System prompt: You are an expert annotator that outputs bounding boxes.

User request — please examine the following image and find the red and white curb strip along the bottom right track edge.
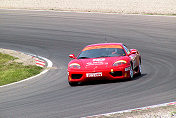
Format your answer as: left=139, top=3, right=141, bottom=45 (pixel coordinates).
left=82, top=101, right=176, bottom=118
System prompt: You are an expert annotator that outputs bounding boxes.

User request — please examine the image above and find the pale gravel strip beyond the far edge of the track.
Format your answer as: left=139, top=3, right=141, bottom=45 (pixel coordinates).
left=0, top=0, right=176, bottom=14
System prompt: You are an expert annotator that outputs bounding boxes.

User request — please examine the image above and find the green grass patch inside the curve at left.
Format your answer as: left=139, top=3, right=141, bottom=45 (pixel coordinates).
left=0, top=53, right=43, bottom=86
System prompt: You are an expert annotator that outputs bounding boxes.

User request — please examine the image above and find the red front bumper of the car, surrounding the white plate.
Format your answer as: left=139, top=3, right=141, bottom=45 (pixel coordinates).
left=68, top=66, right=130, bottom=82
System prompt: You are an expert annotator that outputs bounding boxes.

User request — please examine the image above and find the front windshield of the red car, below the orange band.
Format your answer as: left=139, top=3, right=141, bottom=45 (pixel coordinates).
left=78, top=48, right=126, bottom=59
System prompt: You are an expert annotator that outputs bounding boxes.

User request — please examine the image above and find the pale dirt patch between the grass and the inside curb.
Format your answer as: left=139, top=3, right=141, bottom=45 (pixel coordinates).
left=0, top=48, right=36, bottom=65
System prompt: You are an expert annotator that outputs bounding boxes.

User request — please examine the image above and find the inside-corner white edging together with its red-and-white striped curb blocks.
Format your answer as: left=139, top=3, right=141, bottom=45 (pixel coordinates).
left=0, top=52, right=53, bottom=88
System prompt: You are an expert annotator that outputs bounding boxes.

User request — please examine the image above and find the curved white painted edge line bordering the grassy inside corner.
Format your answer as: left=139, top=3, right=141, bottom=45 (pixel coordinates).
left=0, top=52, right=53, bottom=88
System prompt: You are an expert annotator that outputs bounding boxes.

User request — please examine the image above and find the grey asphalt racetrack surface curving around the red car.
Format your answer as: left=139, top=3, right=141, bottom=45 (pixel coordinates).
left=0, top=10, right=176, bottom=118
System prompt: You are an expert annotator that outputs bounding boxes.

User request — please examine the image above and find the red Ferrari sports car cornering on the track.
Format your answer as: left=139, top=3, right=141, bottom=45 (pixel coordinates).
left=68, top=43, right=141, bottom=86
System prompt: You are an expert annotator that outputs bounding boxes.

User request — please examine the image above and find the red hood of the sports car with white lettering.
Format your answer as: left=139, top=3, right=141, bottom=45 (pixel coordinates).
left=69, top=56, right=127, bottom=70
